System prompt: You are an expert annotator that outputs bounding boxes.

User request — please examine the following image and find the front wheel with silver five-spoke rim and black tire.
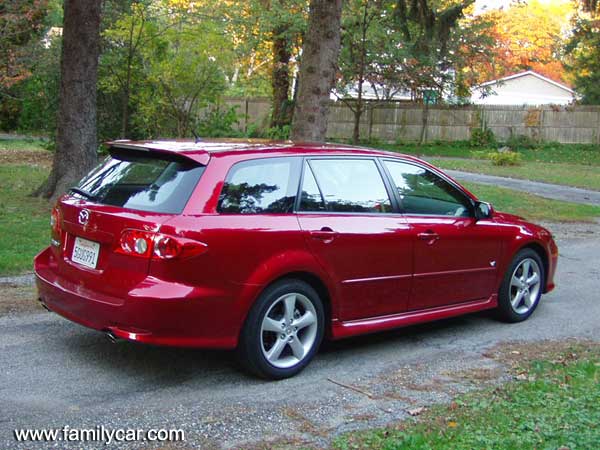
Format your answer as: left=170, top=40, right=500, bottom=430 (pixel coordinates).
left=497, top=248, right=545, bottom=323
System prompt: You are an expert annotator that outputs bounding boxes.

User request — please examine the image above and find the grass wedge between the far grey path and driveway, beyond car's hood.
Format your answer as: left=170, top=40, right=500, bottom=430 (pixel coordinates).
left=463, top=183, right=600, bottom=222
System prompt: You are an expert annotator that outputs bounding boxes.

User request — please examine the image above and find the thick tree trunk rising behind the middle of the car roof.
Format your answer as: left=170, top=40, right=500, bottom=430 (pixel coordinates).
left=291, top=0, right=342, bottom=142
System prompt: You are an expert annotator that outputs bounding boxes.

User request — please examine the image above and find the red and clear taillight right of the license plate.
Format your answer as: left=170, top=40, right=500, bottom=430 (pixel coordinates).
left=115, top=230, right=208, bottom=259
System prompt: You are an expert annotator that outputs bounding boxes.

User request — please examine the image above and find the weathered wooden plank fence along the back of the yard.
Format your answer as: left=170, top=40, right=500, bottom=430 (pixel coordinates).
left=218, top=98, right=600, bottom=144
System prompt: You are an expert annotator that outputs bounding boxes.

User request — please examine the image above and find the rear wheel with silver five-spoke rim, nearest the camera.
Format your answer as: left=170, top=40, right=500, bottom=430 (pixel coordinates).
left=237, top=279, right=325, bottom=380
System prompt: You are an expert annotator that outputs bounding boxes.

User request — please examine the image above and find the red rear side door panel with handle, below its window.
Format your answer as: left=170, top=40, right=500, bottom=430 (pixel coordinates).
left=298, top=214, right=413, bottom=320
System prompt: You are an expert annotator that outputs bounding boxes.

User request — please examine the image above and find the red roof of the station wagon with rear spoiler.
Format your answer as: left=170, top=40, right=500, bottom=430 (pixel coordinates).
left=107, top=139, right=416, bottom=164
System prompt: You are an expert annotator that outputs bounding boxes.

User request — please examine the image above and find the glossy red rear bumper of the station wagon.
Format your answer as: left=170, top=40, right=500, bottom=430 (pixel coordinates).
left=34, top=248, right=243, bottom=349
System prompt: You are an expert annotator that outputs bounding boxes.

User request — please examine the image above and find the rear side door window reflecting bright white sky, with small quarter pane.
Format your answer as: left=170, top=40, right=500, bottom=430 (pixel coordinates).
left=301, top=159, right=392, bottom=213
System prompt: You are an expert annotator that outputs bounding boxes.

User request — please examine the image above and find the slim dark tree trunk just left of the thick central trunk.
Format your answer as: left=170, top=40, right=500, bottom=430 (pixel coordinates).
left=271, top=27, right=292, bottom=127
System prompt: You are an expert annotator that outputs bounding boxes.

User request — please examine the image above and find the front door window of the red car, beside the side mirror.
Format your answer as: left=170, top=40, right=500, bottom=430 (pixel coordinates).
left=385, top=161, right=471, bottom=216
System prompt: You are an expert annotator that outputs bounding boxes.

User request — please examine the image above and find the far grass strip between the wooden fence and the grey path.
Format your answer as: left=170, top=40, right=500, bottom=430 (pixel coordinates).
left=377, top=142, right=600, bottom=191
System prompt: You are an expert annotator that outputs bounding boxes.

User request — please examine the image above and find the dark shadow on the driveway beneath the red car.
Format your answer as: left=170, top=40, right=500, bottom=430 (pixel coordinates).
left=56, top=312, right=492, bottom=391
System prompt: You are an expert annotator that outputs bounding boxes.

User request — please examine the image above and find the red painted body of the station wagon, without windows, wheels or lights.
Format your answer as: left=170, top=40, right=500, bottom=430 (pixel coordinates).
left=35, top=140, right=558, bottom=348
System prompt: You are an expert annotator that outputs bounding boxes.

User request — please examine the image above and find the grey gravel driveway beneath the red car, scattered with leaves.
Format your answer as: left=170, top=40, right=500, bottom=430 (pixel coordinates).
left=0, top=229, right=600, bottom=448
